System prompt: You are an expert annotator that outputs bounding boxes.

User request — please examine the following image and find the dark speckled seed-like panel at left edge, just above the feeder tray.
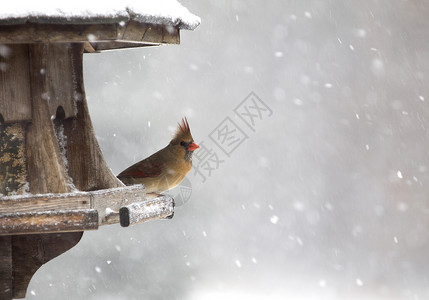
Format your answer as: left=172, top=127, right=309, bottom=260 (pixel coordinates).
left=0, top=123, right=28, bottom=196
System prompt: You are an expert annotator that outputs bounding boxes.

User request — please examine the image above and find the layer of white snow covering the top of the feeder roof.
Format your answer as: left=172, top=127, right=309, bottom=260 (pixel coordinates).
left=0, top=0, right=201, bottom=30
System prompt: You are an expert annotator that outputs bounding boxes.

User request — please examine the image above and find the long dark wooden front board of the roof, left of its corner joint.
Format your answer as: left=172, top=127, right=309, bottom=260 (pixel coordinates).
left=0, top=23, right=117, bottom=44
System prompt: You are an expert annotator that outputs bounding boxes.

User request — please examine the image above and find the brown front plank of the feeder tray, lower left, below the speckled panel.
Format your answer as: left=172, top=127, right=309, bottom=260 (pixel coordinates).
left=0, top=209, right=98, bottom=235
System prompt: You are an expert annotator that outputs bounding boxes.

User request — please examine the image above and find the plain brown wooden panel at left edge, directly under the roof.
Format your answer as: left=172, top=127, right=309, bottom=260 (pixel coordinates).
left=0, top=44, right=31, bottom=123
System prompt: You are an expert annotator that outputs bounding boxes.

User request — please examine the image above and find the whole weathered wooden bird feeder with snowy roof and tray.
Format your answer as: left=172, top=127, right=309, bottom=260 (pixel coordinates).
left=0, top=0, right=199, bottom=299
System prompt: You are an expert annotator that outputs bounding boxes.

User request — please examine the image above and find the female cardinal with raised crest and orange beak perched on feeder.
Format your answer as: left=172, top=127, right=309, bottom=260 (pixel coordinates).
left=118, top=118, right=200, bottom=194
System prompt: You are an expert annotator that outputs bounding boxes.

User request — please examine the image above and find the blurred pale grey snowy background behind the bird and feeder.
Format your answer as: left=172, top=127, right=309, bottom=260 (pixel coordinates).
left=27, top=0, right=429, bottom=300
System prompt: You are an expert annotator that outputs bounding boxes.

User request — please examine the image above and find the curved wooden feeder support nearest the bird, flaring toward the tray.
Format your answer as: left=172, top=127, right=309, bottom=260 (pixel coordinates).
left=62, top=44, right=124, bottom=191
